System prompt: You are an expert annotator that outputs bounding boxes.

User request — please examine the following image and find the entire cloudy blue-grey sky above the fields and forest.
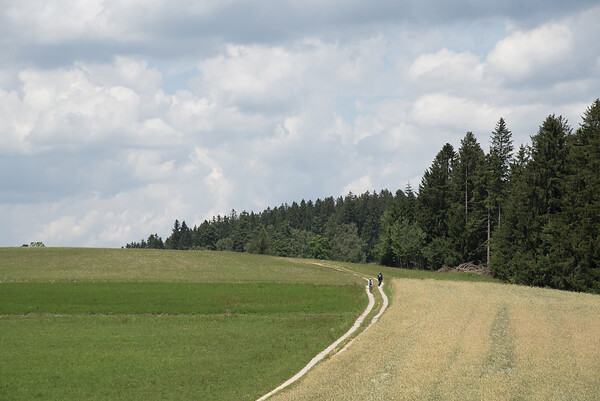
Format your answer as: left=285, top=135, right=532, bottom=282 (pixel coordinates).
left=0, top=0, right=600, bottom=247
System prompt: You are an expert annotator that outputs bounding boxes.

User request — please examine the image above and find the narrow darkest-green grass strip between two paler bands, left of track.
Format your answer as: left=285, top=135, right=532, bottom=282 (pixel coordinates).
left=0, top=282, right=367, bottom=315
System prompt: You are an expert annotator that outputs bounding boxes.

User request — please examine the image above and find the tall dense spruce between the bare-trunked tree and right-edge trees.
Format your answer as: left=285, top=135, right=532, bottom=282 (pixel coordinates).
left=491, top=115, right=571, bottom=286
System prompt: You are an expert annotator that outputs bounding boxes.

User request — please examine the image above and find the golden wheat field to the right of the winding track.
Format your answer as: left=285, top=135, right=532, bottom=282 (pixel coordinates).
left=271, top=279, right=600, bottom=401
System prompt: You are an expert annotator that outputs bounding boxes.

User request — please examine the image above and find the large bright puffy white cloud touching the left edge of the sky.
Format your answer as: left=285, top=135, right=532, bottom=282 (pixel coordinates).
left=0, top=57, right=188, bottom=154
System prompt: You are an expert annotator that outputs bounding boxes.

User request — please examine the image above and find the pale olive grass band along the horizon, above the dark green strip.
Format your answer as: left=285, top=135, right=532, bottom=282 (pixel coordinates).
left=0, top=248, right=356, bottom=285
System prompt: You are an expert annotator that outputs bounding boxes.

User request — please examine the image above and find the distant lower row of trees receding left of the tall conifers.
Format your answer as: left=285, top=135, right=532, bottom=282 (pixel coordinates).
left=127, top=190, right=401, bottom=262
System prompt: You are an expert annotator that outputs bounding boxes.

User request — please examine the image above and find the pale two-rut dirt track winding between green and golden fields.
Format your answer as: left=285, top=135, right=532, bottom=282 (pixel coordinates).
left=256, top=263, right=388, bottom=401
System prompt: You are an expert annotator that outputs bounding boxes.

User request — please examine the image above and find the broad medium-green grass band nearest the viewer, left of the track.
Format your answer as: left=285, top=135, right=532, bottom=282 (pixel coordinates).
left=0, top=313, right=356, bottom=401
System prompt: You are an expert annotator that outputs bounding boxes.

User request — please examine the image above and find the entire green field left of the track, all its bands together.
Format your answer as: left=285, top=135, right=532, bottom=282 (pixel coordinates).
left=0, top=248, right=367, bottom=400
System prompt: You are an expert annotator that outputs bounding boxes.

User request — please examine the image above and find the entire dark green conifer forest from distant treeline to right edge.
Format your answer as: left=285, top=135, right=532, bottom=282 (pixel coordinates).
left=126, top=99, right=600, bottom=293
